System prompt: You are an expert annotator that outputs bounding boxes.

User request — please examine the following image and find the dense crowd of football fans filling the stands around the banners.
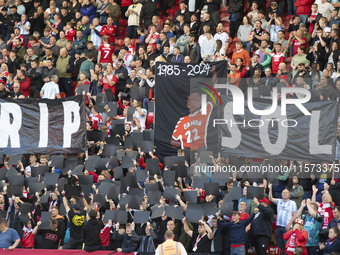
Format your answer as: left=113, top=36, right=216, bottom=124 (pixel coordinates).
left=0, top=0, right=340, bottom=255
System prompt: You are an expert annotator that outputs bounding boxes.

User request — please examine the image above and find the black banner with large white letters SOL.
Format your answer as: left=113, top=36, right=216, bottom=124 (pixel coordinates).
left=216, top=96, right=338, bottom=162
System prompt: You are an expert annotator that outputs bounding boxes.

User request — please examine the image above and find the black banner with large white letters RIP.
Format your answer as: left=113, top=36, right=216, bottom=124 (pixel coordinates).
left=0, top=96, right=86, bottom=154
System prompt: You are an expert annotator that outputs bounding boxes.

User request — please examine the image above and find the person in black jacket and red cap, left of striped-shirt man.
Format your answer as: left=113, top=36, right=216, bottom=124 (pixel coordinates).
left=251, top=198, right=274, bottom=255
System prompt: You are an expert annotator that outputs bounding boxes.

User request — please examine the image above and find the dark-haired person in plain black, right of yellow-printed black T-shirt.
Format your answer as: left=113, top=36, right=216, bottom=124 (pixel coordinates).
left=82, top=209, right=104, bottom=251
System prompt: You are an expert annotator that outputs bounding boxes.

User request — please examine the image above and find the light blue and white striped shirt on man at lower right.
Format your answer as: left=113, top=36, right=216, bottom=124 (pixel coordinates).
left=276, top=199, right=297, bottom=227
